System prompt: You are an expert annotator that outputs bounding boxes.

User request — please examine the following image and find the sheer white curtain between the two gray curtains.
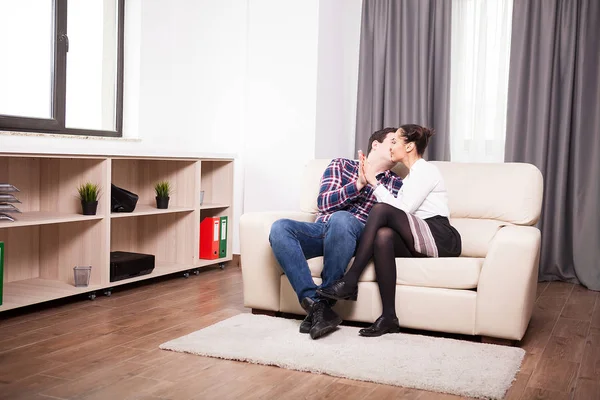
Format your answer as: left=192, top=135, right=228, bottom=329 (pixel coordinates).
left=450, top=0, right=513, bottom=162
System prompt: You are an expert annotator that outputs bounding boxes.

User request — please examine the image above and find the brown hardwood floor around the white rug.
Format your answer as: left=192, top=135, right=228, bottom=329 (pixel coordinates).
left=0, top=266, right=600, bottom=400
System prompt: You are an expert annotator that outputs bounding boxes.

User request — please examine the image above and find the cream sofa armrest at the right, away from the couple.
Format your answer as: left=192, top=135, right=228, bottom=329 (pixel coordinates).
left=475, top=226, right=541, bottom=340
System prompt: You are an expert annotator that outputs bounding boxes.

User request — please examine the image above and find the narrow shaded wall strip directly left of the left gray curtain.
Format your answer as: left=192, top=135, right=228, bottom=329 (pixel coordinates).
left=315, top=0, right=366, bottom=158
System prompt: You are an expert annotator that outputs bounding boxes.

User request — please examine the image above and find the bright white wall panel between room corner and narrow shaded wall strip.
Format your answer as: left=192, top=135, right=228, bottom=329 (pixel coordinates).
left=242, top=0, right=319, bottom=212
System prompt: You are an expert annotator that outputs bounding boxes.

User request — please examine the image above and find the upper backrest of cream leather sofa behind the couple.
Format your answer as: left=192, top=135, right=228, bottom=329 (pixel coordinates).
left=300, top=159, right=543, bottom=225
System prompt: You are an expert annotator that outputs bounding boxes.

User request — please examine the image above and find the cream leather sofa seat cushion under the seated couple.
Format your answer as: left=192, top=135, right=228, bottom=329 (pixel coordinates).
left=308, top=257, right=484, bottom=289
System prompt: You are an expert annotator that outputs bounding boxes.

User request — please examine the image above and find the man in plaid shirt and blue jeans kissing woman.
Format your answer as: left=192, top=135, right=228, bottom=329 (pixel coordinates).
left=269, top=128, right=402, bottom=339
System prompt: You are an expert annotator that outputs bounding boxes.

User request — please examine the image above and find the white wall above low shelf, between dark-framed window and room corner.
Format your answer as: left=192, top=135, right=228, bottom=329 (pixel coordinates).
left=139, top=0, right=246, bottom=153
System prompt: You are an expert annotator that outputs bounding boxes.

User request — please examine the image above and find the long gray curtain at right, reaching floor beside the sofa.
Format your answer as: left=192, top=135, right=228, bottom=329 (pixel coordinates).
left=506, top=0, right=600, bottom=290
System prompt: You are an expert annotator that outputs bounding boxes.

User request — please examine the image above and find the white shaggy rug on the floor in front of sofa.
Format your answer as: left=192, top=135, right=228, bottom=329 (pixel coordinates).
left=160, top=314, right=525, bottom=399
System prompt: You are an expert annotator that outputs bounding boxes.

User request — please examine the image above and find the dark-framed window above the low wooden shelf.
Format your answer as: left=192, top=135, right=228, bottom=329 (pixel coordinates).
left=0, top=0, right=124, bottom=136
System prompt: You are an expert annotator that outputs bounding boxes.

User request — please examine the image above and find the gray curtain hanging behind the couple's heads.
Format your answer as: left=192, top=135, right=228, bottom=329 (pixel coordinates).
left=355, top=0, right=452, bottom=160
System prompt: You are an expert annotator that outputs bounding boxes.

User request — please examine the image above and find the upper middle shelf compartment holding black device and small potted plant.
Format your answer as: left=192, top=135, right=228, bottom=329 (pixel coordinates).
left=111, top=158, right=199, bottom=210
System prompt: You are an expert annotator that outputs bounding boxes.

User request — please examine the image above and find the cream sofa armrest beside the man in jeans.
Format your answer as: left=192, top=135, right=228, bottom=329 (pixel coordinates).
left=240, top=212, right=315, bottom=311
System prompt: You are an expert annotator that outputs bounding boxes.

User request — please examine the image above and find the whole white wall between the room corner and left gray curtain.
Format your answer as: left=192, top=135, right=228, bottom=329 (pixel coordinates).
left=242, top=0, right=362, bottom=216
